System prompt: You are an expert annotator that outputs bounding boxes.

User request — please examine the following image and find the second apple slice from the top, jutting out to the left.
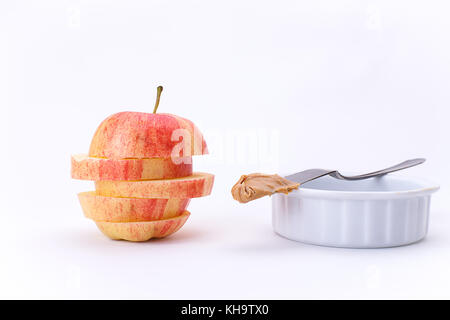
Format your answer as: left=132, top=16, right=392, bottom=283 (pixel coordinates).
left=71, top=154, right=192, bottom=180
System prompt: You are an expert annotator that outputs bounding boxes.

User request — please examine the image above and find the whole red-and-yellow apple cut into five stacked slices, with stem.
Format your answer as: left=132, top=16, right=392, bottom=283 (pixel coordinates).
left=71, top=88, right=214, bottom=241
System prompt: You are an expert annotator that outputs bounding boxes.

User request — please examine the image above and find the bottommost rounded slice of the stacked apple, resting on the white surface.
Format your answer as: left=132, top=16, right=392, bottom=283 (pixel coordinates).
left=95, top=211, right=190, bottom=241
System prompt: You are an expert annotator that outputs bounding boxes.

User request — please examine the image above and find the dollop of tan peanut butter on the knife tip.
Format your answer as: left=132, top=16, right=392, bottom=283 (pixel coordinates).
left=231, top=173, right=300, bottom=203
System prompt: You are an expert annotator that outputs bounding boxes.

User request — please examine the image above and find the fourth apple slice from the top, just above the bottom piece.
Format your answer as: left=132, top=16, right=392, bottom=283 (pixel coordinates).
left=78, top=192, right=190, bottom=222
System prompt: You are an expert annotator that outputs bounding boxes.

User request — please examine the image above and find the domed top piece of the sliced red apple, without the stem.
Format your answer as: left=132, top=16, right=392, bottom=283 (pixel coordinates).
left=89, top=111, right=208, bottom=159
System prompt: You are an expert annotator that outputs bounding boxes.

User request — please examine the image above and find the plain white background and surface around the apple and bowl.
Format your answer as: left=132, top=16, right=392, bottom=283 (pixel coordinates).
left=0, top=0, right=450, bottom=299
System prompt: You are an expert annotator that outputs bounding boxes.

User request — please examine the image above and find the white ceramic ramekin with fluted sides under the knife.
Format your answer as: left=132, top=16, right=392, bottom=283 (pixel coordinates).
left=272, top=174, right=439, bottom=248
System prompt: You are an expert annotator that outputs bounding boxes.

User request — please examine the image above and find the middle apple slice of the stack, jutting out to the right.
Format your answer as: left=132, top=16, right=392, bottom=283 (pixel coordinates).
left=95, top=172, right=214, bottom=199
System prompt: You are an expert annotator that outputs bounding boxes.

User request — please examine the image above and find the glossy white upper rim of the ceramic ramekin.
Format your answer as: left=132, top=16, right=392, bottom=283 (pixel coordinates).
left=287, top=174, right=440, bottom=200
